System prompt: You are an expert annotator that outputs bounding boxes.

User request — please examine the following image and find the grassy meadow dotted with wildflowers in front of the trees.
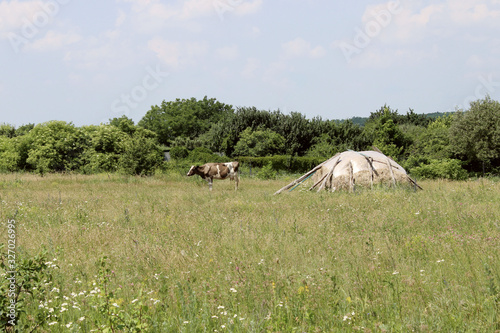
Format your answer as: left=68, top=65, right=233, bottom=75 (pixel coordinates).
left=0, top=174, right=500, bottom=332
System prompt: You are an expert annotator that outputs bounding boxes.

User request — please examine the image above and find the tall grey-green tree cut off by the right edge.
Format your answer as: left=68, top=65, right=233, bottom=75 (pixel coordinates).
left=450, top=96, right=500, bottom=172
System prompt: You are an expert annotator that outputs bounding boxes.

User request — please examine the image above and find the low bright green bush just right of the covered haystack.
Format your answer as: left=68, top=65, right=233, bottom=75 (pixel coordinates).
left=410, top=159, right=468, bottom=180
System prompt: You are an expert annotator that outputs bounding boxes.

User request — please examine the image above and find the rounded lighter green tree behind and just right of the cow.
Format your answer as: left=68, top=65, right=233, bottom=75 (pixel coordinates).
left=234, top=127, right=285, bottom=156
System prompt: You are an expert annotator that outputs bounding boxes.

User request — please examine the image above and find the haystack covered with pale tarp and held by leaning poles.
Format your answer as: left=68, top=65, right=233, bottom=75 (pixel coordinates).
left=275, top=150, right=421, bottom=194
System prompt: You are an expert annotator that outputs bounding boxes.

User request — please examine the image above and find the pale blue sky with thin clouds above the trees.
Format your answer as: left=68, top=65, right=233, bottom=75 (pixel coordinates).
left=0, top=0, right=500, bottom=127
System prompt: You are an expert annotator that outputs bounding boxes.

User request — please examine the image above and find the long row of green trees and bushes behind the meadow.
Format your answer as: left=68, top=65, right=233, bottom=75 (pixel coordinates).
left=0, top=96, right=500, bottom=179
